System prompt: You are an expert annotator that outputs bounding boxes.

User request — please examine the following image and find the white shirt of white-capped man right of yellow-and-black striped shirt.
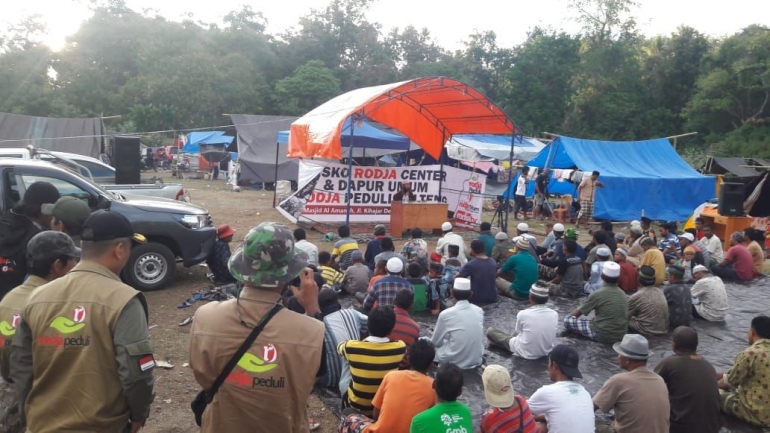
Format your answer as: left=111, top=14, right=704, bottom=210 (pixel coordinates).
left=431, top=301, right=485, bottom=369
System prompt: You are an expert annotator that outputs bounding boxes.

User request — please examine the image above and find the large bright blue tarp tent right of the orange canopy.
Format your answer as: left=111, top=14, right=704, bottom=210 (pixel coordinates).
left=509, top=137, right=715, bottom=221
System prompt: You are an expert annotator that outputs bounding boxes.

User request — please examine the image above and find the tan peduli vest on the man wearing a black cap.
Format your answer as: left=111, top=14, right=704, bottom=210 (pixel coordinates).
left=22, top=261, right=147, bottom=433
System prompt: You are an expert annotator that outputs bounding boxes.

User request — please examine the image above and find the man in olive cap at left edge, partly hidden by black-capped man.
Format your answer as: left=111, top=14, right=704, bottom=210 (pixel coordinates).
left=0, top=231, right=80, bottom=433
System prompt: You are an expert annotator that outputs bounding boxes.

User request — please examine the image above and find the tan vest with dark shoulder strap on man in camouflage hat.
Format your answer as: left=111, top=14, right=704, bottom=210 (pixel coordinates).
left=190, top=287, right=324, bottom=433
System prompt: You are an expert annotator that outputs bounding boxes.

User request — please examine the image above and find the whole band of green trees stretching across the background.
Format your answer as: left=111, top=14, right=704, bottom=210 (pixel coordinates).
left=0, top=0, right=770, bottom=157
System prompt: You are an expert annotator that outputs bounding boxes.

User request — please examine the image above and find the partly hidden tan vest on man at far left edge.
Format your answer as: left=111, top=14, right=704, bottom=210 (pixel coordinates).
left=0, top=275, right=47, bottom=382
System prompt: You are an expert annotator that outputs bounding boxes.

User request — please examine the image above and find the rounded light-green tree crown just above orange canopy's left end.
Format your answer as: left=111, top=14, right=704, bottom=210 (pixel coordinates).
left=275, top=60, right=342, bottom=116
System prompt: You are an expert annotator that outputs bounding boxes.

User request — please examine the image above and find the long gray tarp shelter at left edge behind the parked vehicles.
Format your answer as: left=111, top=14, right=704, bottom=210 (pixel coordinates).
left=0, top=113, right=104, bottom=158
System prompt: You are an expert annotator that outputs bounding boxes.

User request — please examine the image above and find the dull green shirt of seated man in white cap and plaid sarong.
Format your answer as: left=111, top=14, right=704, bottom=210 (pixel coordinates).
left=580, top=283, right=628, bottom=343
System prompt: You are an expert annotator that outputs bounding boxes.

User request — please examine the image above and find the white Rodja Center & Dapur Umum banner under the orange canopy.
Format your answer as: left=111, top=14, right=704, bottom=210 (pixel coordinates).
left=277, top=161, right=487, bottom=227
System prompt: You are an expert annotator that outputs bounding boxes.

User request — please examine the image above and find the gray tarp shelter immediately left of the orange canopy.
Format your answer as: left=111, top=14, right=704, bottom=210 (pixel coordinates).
left=230, top=114, right=299, bottom=183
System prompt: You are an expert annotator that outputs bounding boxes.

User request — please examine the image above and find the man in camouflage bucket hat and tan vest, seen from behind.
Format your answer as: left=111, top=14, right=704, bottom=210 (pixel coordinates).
left=190, top=222, right=324, bottom=433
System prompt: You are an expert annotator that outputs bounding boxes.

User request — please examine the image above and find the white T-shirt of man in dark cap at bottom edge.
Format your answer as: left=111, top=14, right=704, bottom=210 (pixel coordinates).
left=527, top=380, right=596, bottom=433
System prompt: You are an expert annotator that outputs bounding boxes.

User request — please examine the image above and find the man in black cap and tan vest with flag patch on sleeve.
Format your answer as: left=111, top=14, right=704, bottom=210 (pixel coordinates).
left=11, top=210, right=155, bottom=432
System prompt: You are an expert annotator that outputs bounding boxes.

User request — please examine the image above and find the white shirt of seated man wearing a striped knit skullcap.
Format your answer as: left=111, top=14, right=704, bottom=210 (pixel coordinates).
left=509, top=305, right=559, bottom=359
